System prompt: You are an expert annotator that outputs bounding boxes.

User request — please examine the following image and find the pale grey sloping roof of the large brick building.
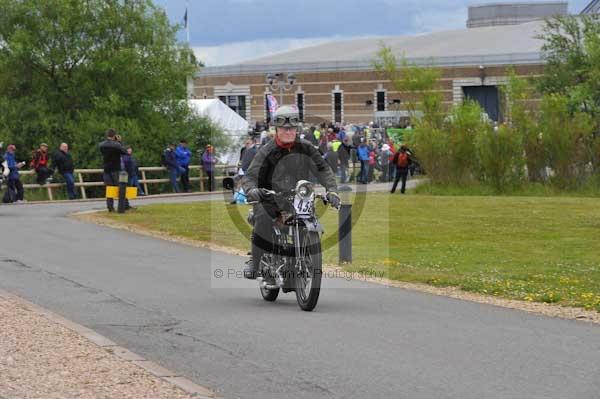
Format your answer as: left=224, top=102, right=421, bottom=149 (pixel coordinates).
left=200, top=21, right=544, bottom=76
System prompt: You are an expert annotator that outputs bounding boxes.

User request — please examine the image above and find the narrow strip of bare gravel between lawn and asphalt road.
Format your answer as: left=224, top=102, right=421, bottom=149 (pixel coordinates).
left=73, top=213, right=600, bottom=324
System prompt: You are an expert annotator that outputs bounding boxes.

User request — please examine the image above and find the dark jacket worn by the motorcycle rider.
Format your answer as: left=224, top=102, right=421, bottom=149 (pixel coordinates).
left=242, top=138, right=337, bottom=192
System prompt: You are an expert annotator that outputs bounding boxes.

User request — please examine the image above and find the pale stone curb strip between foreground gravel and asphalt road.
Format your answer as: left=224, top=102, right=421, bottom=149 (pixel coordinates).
left=0, top=289, right=219, bottom=399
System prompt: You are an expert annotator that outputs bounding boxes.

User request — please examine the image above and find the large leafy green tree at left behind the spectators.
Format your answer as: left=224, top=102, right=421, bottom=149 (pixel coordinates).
left=0, top=0, right=219, bottom=167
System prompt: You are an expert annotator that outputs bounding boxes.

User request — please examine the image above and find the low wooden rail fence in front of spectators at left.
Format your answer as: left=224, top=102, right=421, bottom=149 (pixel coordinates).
left=19, top=165, right=235, bottom=201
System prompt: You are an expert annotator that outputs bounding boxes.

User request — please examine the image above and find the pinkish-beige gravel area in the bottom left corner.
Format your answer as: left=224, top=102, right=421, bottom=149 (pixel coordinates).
left=0, top=294, right=191, bottom=399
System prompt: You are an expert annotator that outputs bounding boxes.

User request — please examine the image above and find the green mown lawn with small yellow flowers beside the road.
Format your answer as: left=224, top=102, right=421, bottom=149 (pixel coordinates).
left=104, top=194, right=600, bottom=311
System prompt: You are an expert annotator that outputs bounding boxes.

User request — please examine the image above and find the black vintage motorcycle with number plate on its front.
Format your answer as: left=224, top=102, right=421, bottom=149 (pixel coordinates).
left=248, top=180, right=338, bottom=312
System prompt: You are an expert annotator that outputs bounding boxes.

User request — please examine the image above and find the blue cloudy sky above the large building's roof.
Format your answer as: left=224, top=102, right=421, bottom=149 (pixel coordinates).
left=155, top=0, right=590, bottom=65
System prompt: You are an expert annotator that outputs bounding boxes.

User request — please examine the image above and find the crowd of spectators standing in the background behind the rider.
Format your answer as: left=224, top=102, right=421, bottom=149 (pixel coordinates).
left=0, top=124, right=418, bottom=206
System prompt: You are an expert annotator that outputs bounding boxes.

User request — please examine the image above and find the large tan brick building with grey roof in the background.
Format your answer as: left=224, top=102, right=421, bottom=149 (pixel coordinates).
left=193, top=2, right=580, bottom=123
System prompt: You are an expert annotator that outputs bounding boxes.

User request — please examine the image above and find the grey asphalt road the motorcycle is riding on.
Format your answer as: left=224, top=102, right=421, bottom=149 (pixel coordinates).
left=0, top=192, right=600, bottom=399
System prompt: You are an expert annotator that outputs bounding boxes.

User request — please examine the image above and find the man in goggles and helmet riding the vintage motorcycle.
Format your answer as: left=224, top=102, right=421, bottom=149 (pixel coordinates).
left=242, top=106, right=340, bottom=280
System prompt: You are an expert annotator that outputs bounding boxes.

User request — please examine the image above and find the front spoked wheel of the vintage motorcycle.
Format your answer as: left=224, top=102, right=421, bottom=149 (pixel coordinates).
left=296, top=231, right=322, bottom=312
